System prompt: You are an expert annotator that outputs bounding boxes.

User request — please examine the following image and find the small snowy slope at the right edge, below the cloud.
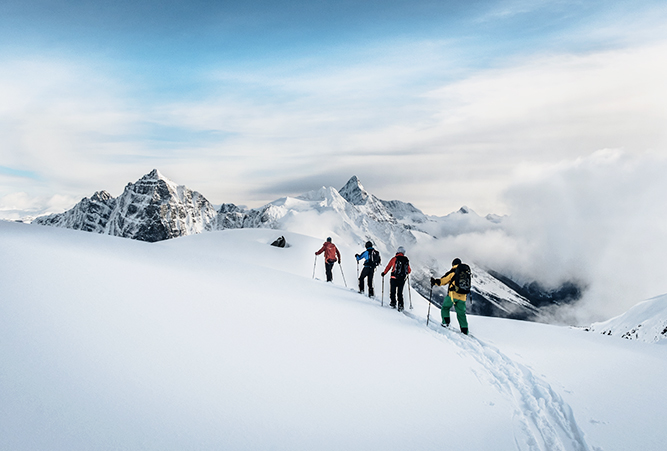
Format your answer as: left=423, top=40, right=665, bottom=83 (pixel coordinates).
left=587, top=295, right=667, bottom=344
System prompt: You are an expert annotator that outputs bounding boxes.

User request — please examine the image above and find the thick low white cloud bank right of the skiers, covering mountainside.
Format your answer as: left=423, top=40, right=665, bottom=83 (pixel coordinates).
left=428, top=150, right=667, bottom=324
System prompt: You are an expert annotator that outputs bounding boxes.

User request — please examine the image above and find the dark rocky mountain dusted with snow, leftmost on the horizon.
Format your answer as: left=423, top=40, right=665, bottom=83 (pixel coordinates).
left=34, top=169, right=216, bottom=242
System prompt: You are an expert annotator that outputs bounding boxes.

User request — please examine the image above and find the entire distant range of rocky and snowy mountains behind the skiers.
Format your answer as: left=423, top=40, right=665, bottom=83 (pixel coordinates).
left=33, top=169, right=581, bottom=320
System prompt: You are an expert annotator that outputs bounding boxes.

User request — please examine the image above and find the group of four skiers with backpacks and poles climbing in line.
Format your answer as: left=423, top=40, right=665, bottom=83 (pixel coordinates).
left=313, top=237, right=472, bottom=335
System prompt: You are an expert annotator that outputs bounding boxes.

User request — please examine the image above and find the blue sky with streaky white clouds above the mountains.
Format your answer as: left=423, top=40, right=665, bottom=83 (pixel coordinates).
left=0, top=0, right=667, bottom=217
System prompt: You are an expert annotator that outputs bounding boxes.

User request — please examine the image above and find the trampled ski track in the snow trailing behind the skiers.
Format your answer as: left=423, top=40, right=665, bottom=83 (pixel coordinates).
left=366, top=300, right=603, bottom=451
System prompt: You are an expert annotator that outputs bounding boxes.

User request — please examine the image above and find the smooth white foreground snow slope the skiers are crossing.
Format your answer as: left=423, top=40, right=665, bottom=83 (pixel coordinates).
left=0, top=222, right=667, bottom=451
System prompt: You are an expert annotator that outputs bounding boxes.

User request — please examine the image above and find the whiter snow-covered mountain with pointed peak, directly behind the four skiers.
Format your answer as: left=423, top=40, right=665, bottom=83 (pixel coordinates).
left=211, top=176, right=564, bottom=319
